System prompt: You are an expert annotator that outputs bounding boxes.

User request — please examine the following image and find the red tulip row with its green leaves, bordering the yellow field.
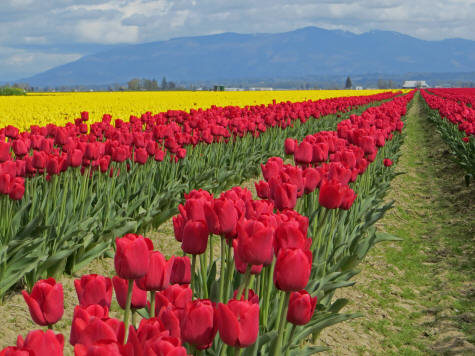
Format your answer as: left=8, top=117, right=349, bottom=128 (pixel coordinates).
left=0, top=93, right=398, bottom=297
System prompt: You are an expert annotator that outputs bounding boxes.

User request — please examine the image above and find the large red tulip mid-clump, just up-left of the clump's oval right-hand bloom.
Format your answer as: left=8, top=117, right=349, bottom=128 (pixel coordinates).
left=237, top=219, right=274, bottom=266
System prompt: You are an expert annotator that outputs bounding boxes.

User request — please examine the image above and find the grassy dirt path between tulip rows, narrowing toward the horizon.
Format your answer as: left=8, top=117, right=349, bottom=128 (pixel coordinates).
left=320, top=95, right=475, bottom=356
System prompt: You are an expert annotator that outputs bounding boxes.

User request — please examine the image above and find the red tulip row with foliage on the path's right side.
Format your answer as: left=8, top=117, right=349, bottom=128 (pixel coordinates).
left=421, top=89, right=475, bottom=184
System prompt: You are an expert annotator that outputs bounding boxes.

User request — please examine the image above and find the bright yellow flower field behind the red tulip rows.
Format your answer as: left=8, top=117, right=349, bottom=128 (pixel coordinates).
left=0, top=90, right=404, bottom=131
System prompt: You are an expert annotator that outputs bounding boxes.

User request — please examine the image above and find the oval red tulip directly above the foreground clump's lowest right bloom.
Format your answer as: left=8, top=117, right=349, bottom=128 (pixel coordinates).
left=274, top=248, right=312, bottom=292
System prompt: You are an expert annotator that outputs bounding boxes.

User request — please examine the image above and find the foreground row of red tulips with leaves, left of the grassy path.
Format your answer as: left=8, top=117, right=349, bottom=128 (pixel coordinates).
left=0, top=90, right=413, bottom=356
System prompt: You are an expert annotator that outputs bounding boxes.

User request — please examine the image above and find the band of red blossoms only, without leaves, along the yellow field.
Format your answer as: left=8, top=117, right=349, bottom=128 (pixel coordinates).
left=0, top=92, right=398, bottom=200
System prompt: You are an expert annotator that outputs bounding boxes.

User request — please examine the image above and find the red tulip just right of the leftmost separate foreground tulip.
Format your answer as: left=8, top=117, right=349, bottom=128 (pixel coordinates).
left=74, top=274, right=112, bottom=308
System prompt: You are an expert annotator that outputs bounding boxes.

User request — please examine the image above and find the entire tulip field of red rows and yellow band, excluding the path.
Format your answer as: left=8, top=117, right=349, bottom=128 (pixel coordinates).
left=0, top=89, right=475, bottom=356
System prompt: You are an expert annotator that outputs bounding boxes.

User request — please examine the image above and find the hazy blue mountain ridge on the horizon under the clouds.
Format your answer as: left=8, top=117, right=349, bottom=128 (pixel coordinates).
left=22, top=27, right=475, bottom=86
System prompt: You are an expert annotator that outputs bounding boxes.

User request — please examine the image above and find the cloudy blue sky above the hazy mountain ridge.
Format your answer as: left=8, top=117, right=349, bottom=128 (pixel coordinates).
left=0, top=0, right=475, bottom=82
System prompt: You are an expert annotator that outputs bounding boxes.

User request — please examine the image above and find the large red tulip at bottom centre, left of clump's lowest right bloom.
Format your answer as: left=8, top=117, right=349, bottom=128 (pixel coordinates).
left=216, top=299, right=259, bottom=347
